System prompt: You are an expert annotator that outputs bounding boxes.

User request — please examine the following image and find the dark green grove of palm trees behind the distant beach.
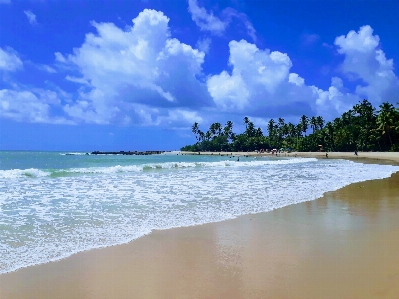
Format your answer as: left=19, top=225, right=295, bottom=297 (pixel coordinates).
left=181, top=100, right=399, bottom=151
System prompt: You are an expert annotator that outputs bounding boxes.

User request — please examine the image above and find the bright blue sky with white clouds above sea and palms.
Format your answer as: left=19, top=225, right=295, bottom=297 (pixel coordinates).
left=0, top=0, right=399, bottom=151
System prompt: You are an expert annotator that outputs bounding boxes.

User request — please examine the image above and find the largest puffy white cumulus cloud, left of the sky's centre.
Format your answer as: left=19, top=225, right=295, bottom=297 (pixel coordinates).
left=59, top=9, right=212, bottom=123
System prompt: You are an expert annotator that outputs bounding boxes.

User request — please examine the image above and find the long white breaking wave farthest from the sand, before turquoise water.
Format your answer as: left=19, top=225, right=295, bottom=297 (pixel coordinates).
left=0, top=158, right=317, bottom=179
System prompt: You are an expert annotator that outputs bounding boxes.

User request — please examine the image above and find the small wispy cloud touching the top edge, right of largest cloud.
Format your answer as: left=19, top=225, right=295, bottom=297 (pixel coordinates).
left=188, top=0, right=228, bottom=35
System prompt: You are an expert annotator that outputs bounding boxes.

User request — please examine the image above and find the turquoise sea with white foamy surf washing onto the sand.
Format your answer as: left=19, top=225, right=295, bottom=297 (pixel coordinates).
left=0, top=151, right=399, bottom=273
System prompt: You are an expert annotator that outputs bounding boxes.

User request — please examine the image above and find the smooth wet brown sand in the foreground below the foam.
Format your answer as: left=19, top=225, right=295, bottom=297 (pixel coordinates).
left=0, top=173, right=399, bottom=299
